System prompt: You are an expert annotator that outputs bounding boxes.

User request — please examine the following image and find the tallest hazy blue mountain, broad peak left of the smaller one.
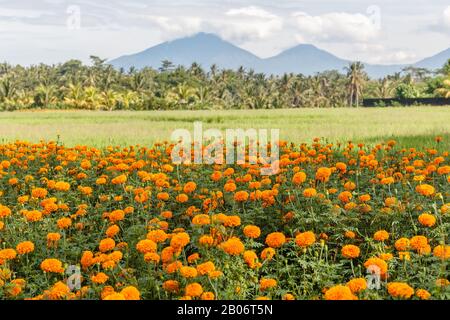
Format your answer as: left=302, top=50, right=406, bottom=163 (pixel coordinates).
left=109, top=33, right=260, bottom=70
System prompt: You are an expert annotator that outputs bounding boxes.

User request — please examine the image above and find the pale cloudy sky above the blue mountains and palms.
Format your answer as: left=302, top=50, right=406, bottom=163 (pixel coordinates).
left=0, top=0, right=450, bottom=65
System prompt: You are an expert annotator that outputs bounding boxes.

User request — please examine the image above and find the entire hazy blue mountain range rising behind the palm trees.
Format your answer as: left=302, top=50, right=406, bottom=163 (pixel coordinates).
left=109, top=33, right=450, bottom=78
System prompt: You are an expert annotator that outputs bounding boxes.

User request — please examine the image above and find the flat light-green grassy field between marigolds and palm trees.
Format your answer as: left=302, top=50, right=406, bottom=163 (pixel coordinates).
left=0, top=107, right=450, bottom=148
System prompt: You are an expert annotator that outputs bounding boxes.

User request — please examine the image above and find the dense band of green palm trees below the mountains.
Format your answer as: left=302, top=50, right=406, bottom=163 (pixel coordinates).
left=0, top=57, right=450, bottom=110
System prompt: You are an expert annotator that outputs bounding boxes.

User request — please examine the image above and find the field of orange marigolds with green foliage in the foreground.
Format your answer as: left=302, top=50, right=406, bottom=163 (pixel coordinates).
left=0, top=138, right=450, bottom=300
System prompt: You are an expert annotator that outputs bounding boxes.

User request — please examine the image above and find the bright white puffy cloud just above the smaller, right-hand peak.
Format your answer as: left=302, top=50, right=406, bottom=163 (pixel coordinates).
left=293, top=12, right=380, bottom=42
